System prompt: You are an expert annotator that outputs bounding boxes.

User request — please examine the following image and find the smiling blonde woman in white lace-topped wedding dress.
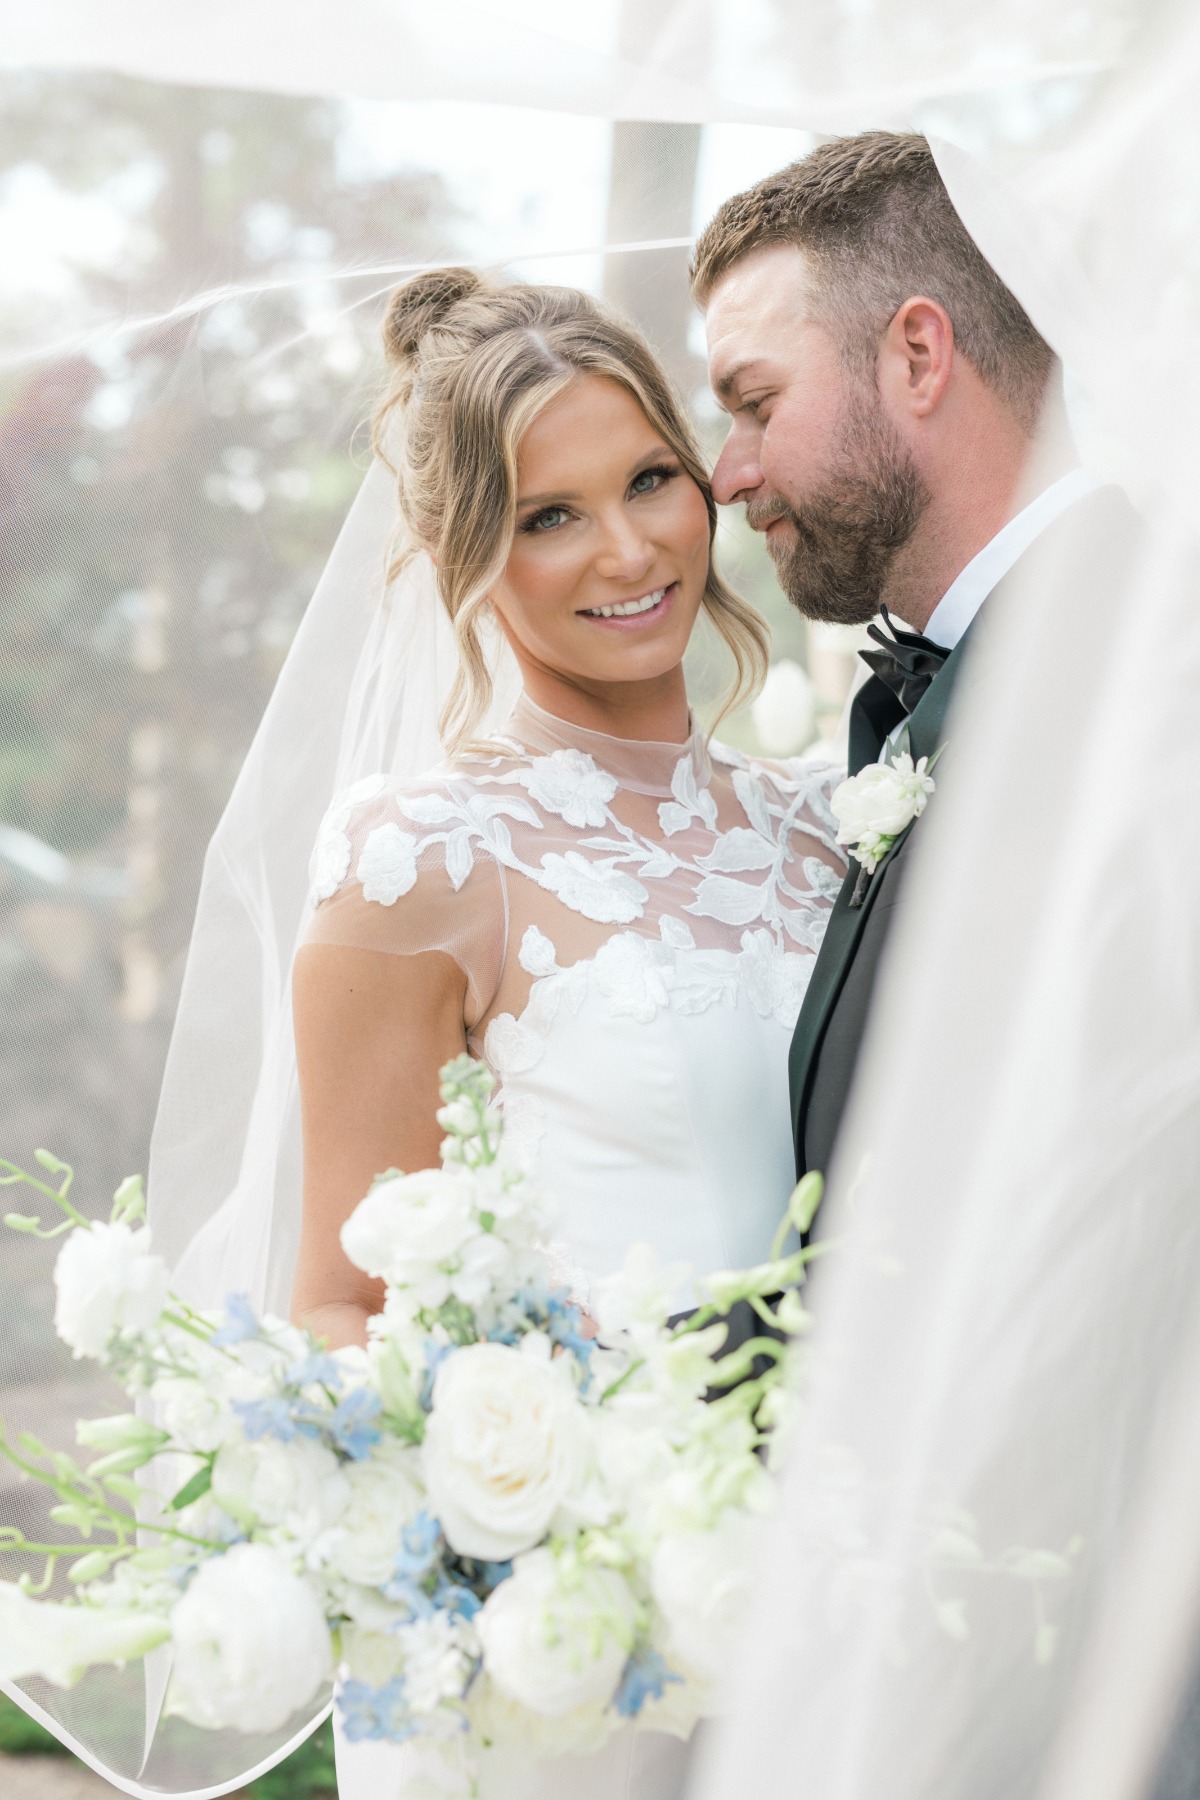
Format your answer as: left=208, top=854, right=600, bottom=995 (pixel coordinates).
left=284, top=270, right=844, bottom=1800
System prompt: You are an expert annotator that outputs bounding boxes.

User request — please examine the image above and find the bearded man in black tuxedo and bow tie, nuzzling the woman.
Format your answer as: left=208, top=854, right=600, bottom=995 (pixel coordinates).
left=693, top=131, right=1132, bottom=1175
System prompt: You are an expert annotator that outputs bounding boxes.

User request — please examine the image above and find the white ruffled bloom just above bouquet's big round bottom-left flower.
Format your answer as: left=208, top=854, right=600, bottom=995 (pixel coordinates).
left=212, top=1438, right=351, bottom=1544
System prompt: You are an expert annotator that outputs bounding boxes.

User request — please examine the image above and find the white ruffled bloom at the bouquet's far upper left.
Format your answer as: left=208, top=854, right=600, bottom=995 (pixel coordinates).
left=54, top=1224, right=167, bottom=1357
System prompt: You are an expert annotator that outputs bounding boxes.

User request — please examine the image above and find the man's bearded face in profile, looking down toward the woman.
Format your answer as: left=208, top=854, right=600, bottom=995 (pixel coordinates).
left=705, top=245, right=928, bottom=625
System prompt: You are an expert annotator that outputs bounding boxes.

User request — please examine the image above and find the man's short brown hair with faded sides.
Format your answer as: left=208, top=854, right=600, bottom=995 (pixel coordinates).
left=691, top=131, right=1054, bottom=430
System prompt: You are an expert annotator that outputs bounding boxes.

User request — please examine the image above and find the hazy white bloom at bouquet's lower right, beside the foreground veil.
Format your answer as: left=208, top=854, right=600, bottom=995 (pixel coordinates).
left=649, top=1508, right=756, bottom=1681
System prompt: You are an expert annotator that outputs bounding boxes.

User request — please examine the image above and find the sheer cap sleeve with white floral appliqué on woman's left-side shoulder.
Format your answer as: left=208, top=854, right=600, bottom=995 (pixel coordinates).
left=304, top=776, right=507, bottom=1030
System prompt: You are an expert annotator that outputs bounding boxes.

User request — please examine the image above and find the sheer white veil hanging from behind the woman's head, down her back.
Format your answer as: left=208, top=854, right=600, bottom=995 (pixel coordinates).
left=149, top=463, right=518, bottom=1316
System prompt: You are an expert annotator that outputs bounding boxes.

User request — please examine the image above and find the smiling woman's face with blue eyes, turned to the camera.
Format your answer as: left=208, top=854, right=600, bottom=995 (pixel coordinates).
left=491, top=374, right=709, bottom=684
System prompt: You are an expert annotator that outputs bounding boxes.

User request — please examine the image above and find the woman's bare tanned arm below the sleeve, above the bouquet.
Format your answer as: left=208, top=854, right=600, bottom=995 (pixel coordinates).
left=291, top=943, right=466, bottom=1348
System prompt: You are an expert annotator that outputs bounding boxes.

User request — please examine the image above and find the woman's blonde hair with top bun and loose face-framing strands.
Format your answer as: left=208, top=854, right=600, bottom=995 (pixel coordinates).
left=374, top=268, right=770, bottom=751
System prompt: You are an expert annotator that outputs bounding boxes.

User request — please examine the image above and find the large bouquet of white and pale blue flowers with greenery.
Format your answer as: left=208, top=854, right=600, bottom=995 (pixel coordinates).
left=0, top=1057, right=820, bottom=1778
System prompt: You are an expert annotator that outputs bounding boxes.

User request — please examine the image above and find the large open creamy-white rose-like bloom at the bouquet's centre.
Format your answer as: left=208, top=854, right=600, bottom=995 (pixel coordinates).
left=421, top=1343, right=587, bottom=1562
